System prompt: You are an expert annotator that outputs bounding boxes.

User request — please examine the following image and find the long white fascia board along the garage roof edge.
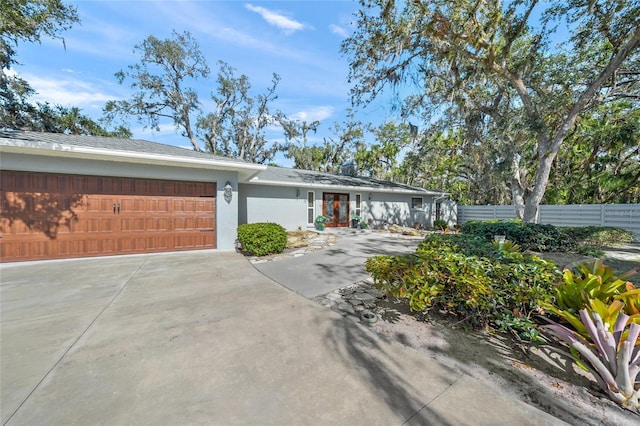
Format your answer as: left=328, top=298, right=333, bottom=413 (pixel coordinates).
left=0, top=140, right=267, bottom=179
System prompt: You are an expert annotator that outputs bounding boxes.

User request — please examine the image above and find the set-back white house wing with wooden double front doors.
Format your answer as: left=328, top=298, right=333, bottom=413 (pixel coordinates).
left=238, top=167, right=457, bottom=230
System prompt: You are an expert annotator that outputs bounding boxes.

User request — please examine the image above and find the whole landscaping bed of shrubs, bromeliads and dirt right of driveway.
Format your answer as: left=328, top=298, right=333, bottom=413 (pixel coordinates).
left=366, top=222, right=640, bottom=425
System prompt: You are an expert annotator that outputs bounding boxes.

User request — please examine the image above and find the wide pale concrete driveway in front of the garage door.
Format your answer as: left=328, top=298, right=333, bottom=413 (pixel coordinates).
left=0, top=251, right=559, bottom=425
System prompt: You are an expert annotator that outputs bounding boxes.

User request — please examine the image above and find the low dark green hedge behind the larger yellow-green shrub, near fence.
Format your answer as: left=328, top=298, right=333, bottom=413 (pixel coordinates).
left=461, top=220, right=578, bottom=252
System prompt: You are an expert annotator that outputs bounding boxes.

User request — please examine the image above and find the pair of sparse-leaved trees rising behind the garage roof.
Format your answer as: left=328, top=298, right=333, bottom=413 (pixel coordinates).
left=105, top=31, right=286, bottom=163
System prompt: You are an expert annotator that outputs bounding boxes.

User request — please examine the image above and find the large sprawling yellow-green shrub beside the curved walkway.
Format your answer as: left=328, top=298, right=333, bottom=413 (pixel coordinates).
left=365, top=234, right=558, bottom=338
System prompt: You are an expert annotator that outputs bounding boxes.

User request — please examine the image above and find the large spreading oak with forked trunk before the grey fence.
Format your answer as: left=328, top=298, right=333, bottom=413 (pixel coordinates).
left=342, top=0, right=640, bottom=221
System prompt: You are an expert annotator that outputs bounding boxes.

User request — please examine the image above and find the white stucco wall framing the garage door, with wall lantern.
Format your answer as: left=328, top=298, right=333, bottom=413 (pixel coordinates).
left=0, top=152, right=238, bottom=250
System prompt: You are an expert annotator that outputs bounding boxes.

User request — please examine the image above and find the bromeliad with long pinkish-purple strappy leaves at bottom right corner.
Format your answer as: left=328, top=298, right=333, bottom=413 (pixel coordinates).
left=544, top=309, right=640, bottom=411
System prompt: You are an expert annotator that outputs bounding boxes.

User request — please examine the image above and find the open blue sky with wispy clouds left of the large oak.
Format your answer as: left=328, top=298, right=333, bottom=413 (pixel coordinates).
left=14, top=0, right=400, bottom=165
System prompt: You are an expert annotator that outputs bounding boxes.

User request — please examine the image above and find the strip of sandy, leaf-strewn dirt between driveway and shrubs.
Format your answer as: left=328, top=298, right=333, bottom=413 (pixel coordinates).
left=376, top=300, right=640, bottom=426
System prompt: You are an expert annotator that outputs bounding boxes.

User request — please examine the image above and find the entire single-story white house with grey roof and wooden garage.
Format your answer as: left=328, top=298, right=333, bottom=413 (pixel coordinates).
left=0, top=130, right=456, bottom=262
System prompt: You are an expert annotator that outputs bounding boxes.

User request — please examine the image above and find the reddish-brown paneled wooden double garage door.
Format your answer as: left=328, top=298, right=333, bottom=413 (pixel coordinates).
left=0, top=171, right=216, bottom=262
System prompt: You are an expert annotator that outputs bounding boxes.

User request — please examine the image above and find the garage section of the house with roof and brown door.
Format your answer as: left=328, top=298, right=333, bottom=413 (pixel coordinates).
left=0, top=130, right=266, bottom=262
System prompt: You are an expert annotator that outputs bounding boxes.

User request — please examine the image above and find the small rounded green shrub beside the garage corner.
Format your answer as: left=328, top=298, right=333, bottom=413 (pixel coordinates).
left=238, top=223, right=287, bottom=256
